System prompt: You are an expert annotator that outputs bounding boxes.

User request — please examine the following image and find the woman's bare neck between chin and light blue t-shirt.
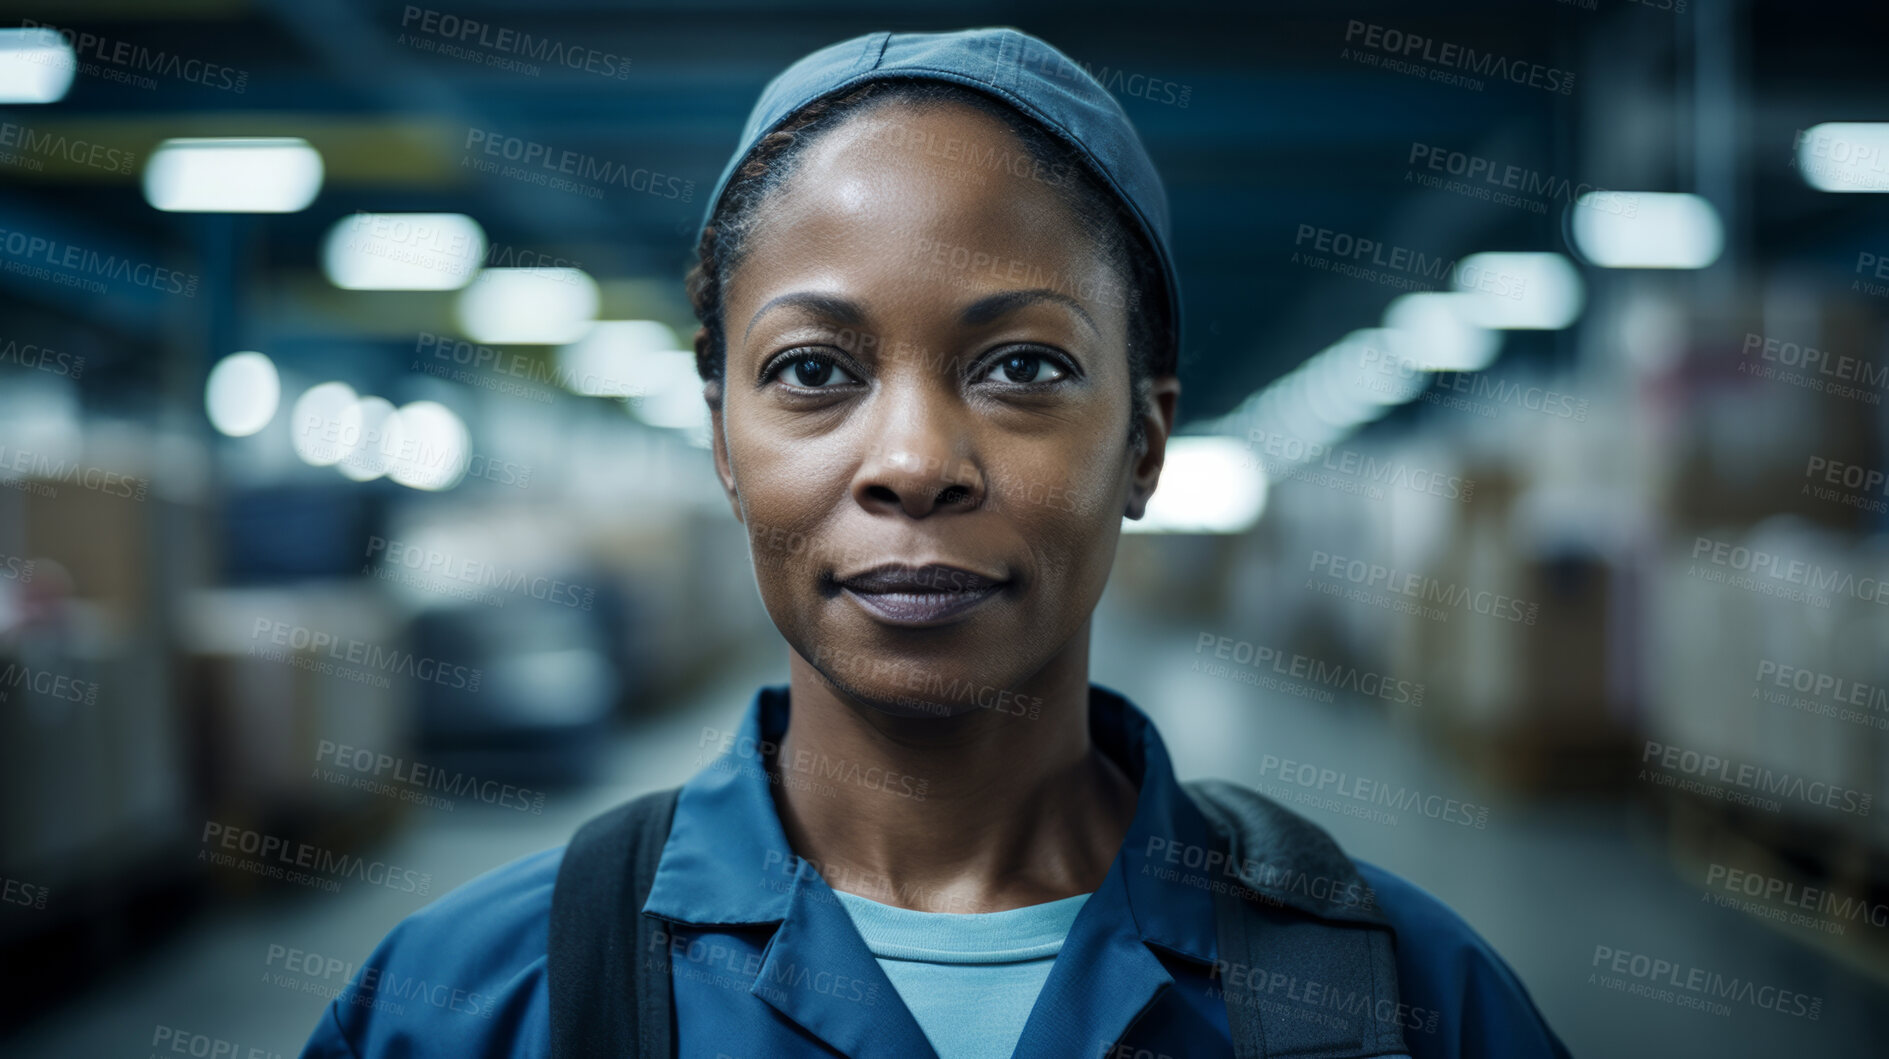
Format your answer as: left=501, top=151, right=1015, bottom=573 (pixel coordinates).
left=769, top=627, right=1137, bottom=912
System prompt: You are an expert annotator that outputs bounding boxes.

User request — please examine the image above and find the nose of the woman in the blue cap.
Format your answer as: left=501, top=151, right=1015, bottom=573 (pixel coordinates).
left=852, top=396, right=984, bottom=519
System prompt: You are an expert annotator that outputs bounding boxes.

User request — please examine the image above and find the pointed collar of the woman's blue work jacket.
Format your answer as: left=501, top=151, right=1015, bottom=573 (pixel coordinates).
left=642, top=685, right=1218, bottom=963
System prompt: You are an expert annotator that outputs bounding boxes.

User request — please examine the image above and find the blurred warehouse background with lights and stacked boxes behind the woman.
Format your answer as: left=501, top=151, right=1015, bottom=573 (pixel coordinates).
left=0, top=0, right=1889, bottom=1055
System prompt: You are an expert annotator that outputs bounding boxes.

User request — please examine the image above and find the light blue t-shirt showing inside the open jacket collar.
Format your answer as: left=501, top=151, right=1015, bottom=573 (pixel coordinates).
left=833, top=891, right=1088, bottom=1059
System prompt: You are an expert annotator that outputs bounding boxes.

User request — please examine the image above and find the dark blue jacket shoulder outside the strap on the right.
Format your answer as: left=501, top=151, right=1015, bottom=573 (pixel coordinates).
left=1353, top=861, right=1568, bottom=1059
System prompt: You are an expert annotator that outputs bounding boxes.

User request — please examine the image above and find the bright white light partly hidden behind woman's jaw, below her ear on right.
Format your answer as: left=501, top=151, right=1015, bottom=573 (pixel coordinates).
left=1122, top=434, right=1266, bottom=532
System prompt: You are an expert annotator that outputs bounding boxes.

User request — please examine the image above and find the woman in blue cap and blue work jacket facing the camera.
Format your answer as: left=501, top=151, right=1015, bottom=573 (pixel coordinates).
left=304, top=30, right=1564, bottom=1059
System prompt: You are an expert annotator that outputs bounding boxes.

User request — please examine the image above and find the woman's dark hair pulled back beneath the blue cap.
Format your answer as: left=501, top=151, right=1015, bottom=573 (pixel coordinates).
left=688, top=79, right=1175, bottom=447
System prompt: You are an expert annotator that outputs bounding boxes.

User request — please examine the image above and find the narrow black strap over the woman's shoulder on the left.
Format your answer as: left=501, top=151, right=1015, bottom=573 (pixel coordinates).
left=548, top=787, right=680, bottom=1059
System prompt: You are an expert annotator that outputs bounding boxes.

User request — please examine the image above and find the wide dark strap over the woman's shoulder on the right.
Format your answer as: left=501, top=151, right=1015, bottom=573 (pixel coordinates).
left=1183, top=780, right=1409, bottom=1059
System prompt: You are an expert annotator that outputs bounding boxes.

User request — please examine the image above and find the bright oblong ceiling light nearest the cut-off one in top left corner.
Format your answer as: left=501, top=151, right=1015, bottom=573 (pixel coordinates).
left=144, top=136, right=321, bottom=213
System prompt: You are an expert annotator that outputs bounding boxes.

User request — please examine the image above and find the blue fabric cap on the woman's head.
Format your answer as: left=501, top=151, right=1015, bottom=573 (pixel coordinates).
left=697, top=28, right=1181, bottom=364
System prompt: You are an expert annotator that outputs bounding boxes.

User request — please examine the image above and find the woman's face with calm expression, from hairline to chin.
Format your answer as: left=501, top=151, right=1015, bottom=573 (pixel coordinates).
left=714, top=104, right=1177, bottom=715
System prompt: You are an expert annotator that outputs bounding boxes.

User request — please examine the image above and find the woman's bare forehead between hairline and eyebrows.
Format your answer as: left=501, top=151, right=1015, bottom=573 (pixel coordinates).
left=729, top=102, right=1122, bottom=330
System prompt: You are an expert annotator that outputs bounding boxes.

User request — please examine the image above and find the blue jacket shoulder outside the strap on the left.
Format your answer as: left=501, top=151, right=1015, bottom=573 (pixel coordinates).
left=302, top=846, right=565, bottom=1059
